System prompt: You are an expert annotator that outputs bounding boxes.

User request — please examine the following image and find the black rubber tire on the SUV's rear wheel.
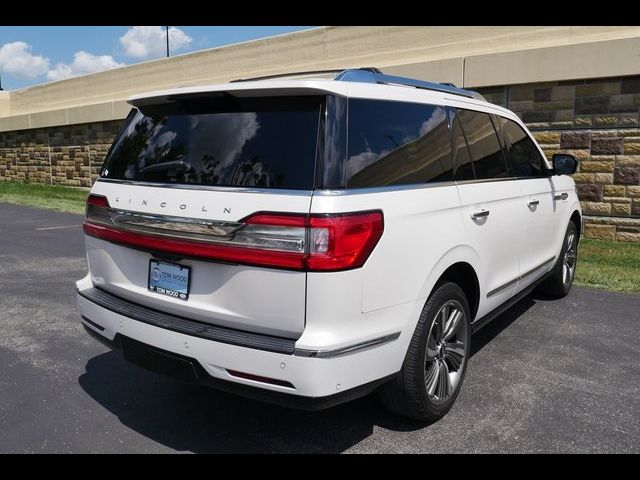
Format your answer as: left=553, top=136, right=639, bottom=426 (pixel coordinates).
left=378, top=282, right=471, bottom=423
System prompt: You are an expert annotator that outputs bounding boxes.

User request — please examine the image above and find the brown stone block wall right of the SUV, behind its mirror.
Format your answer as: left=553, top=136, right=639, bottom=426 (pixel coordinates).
left=480, top=76, right=640, bottom=241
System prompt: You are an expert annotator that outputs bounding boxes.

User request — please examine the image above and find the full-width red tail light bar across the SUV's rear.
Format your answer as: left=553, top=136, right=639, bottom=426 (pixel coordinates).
left=84, top=195, right=384, bottom=272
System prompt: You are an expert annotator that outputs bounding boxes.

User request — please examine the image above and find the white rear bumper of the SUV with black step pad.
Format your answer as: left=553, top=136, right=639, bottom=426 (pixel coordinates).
left=77, top=282, right=402, bottom=404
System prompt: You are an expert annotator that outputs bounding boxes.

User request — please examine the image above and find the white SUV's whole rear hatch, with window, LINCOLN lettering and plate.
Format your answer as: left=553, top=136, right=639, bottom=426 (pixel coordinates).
left=85, top=93, right=324, bottom=338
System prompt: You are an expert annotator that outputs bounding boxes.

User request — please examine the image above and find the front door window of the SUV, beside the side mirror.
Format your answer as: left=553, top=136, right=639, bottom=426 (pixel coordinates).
left=500, top=117, right=547, bottom=177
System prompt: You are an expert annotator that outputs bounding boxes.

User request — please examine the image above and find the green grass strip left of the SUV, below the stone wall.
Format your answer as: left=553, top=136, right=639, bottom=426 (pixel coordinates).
left=0, top=182, right=88, bottom=213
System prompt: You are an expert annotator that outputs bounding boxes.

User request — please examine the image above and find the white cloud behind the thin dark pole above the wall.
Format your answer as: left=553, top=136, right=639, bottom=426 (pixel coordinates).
left=120, top=26, right=193, bottom=60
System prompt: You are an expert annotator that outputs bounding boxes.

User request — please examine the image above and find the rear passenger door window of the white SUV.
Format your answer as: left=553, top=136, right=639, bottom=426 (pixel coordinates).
left=458, top=109, right=507, bottom=180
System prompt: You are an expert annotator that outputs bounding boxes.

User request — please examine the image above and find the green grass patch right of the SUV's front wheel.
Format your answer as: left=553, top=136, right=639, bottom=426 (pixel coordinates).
left=575, top=238, right=640, bottom=293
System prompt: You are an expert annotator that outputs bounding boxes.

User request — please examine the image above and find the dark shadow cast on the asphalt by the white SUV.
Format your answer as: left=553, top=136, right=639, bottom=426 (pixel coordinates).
left=79, top=297, right=536, bottom=453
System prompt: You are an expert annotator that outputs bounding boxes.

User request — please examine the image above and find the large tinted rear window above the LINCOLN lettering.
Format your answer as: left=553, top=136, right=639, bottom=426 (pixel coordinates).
left=102, top=95, right=324, bottom=190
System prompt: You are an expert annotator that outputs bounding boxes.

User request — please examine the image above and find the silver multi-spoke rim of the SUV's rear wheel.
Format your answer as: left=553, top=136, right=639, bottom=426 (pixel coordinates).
left=424, top=300, right=467, bottom=403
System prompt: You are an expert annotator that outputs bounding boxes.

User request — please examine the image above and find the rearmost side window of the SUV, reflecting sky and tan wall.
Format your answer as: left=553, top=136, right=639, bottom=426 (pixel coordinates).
left=345, top=99, right=453, bottom=188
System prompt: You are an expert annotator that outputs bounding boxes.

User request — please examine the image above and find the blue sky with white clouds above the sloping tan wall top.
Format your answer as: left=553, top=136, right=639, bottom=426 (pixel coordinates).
left=0, top=26, right=313, bottom=90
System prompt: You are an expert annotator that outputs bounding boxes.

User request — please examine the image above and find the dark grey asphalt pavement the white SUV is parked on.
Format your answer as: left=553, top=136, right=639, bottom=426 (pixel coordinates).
left=0, top=204, right=640, bottom=453
